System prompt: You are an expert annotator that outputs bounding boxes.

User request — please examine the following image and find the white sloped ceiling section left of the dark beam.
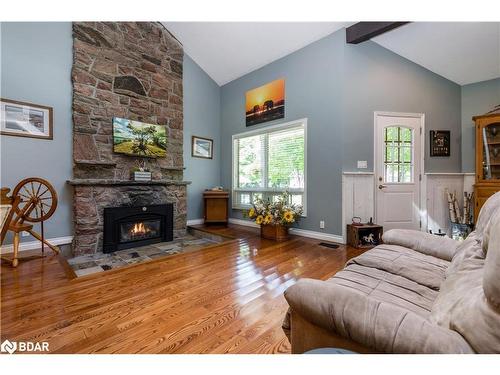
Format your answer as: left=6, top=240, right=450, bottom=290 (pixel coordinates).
left=163, top=22, right=350, bottom=86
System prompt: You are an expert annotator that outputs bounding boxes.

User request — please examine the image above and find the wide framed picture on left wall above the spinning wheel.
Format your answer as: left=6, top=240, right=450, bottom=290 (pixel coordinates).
left=0, top=98, right=53, bottom=139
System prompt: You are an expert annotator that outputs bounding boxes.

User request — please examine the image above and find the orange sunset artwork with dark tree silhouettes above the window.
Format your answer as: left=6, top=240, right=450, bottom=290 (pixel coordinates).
left=245, top=79, right=285, bottom=126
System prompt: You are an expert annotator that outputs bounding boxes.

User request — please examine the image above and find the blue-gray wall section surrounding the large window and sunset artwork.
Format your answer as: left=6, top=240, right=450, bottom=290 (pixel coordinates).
left=221, top=33, right=343, bottom=233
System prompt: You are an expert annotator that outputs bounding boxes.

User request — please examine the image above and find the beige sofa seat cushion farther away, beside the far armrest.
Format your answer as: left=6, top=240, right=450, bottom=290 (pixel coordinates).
left=347, top=244, right=450, bottom=290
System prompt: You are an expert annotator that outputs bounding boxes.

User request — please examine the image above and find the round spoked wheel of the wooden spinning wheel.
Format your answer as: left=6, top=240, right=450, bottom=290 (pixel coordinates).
left=12, top=177, right=57, bottom=222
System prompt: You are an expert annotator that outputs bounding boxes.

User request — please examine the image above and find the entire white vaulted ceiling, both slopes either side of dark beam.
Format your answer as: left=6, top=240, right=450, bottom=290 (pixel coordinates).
left=163, top=22, right=500, bottom=85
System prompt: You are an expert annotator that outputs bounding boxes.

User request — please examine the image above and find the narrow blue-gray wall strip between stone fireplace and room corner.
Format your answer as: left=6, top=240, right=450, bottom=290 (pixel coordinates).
left=183, top=54, right=221, bottom=220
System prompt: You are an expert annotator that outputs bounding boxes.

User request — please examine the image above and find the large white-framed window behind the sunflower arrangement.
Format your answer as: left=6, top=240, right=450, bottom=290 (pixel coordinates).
left=233, top=119, right=306, bottom=212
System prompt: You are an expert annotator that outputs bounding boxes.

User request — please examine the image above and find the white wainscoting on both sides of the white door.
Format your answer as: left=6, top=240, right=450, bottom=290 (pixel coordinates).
left=342, top=172, right=475, bottom=240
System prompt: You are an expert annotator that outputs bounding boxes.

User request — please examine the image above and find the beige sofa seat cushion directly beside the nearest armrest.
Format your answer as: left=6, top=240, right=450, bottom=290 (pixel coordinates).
left=327, top=264, right=438, bottom=317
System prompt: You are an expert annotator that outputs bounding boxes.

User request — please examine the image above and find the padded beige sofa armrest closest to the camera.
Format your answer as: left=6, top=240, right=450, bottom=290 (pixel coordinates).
left=285, top=279, right=473, bottom=354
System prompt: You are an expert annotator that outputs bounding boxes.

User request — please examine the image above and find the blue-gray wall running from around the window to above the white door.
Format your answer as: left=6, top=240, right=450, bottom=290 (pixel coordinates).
left=221, top=30, right=461, bottom=235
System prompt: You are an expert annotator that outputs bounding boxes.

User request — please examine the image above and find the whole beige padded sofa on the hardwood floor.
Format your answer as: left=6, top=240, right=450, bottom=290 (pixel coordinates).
left=283, top=192, right=500, bottom=353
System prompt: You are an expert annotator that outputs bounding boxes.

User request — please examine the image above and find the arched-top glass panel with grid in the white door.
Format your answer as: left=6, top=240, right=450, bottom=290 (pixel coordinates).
left=384, top=126, right=414, bottom=183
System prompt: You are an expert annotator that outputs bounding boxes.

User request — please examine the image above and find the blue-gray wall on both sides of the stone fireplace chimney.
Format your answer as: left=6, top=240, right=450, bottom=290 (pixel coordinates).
left=0, top=22, right=220, bottom=242
